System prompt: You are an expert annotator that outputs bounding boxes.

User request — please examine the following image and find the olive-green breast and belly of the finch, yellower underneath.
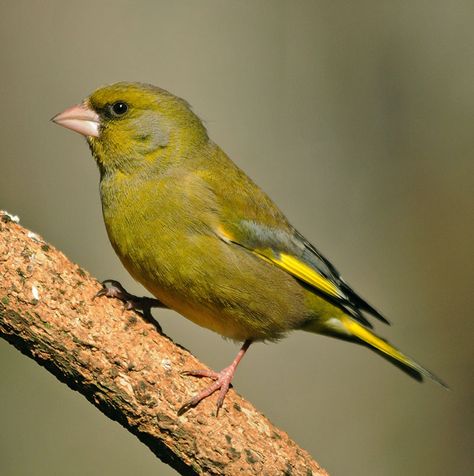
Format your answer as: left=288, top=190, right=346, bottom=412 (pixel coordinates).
left=101, top=169, right=305, bottom=340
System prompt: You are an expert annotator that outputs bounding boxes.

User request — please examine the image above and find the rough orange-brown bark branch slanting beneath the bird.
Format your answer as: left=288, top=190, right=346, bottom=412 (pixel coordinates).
left=0, top=212, right=327, bottom=476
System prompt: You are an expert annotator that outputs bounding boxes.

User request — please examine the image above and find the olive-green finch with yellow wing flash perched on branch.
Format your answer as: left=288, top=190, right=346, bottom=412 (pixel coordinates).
left=52, top=82, right=447, bottom=415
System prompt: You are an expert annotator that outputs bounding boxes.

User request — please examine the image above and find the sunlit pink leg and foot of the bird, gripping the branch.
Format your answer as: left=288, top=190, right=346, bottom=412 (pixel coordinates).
left=178, top=340, right=252, bottom=416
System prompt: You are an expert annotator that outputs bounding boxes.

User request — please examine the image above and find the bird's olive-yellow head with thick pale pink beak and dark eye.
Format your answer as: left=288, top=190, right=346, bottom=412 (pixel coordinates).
left=52, top=82, right=208, bottom=174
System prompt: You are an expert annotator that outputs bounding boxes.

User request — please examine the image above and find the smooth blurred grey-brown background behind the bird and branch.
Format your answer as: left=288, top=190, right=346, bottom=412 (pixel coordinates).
left=0, top=0, right=474, bottom=476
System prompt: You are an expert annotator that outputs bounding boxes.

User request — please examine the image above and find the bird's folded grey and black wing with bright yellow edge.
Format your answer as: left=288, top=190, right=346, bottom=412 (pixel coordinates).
left=217, top=220, right=388, bottom=327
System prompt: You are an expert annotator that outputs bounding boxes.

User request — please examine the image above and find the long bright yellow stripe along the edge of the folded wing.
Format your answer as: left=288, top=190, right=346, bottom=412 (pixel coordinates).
left=255, top=250, right=343, bottom=298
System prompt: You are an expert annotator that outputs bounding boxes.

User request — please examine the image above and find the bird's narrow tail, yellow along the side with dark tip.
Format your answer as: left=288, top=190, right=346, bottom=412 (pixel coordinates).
left=307, top=314, right=449, bottom=388
